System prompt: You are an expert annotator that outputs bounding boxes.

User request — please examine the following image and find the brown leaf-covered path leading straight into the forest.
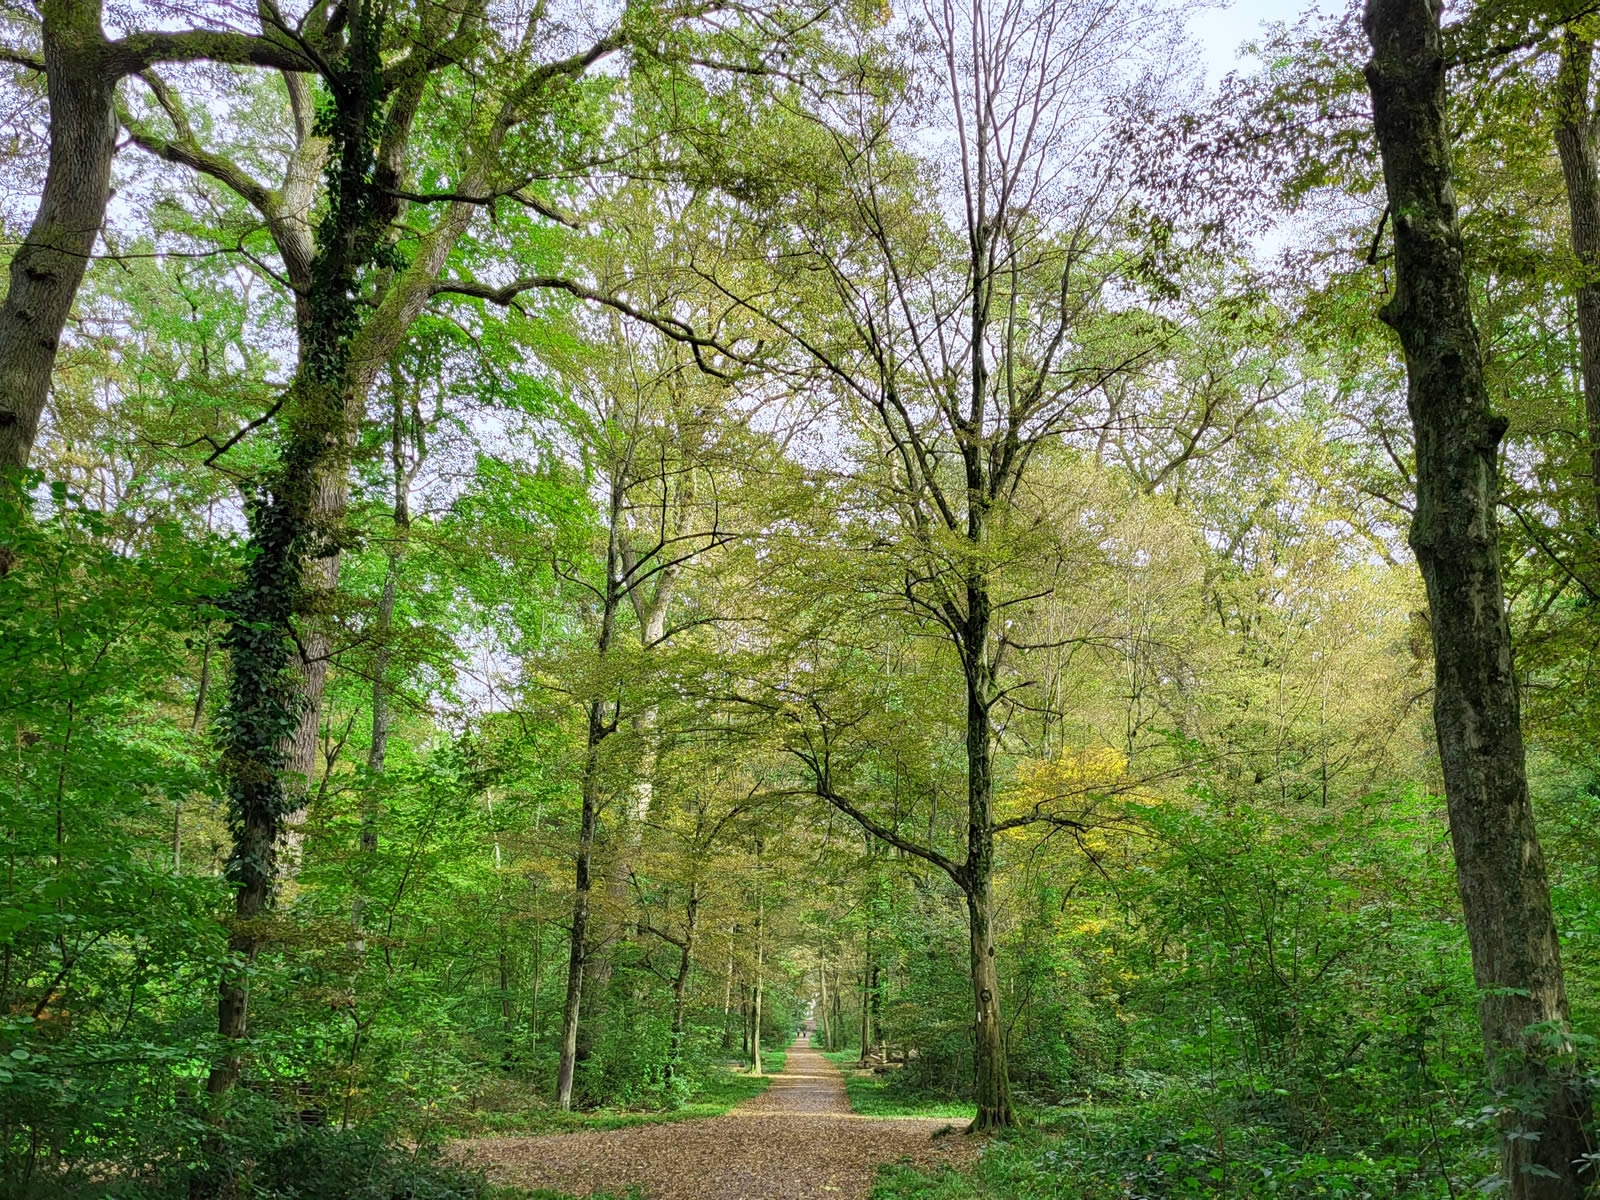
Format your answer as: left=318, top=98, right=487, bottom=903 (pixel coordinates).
left=461, top=1038, right=978, bottom=1200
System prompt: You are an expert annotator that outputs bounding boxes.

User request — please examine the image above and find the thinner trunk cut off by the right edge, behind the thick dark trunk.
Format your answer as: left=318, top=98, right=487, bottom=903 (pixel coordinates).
left=1555, top=29, right=1600, bottom=517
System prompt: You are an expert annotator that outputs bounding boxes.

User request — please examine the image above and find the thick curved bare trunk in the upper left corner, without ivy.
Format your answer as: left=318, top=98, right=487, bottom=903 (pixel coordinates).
left=0, top=10, right=117, bottom=478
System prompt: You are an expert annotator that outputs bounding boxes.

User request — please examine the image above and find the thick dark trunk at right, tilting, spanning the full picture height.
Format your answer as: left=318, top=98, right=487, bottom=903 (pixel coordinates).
left=1366, top=0, right=1590, bottom=1200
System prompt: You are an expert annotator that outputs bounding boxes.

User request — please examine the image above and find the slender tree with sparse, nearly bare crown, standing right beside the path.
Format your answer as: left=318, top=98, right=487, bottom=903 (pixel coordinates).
left=728, top=0, right=1166, bottom=1130
